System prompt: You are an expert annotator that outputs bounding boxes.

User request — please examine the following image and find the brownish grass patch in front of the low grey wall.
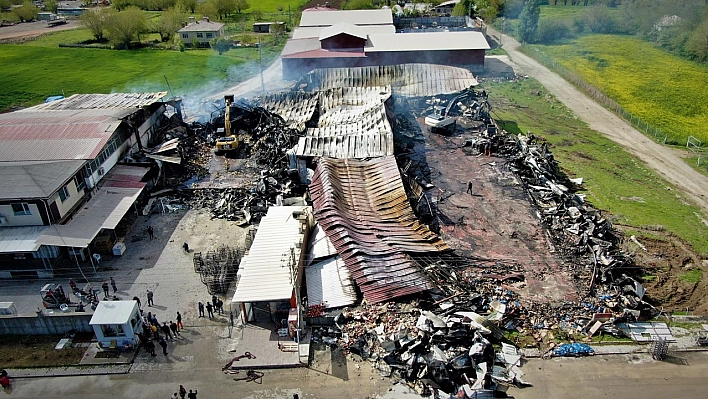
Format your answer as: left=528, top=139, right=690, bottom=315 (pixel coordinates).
left=0, top=335, right=86, bottom=368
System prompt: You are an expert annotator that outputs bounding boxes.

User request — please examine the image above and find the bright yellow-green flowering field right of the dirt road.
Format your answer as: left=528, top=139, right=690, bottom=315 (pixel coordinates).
left=530, top=35, right=708, bottom=145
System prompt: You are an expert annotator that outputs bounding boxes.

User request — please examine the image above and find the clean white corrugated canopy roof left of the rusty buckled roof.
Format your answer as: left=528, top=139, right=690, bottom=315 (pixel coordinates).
left=232, top=206, right=311, bottom=303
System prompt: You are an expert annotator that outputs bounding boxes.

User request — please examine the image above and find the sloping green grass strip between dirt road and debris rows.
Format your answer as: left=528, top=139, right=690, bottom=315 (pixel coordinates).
left=485, top=79, right=708, bottom=254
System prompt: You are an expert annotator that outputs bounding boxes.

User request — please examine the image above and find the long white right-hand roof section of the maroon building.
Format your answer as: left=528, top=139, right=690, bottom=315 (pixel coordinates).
left=364, top=31, right=490, bottom=53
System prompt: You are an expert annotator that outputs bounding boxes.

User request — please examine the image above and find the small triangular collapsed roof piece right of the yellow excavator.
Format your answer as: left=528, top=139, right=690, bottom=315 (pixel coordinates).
left=261, top=91, right=317, bottom=131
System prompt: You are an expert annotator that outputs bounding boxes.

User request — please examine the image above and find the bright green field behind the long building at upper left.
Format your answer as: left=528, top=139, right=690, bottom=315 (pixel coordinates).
left=0, top=29, right=282, bottom=111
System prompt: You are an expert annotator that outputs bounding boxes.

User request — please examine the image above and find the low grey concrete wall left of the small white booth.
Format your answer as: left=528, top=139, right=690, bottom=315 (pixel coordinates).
left=0, top=311, right=93, bottom=336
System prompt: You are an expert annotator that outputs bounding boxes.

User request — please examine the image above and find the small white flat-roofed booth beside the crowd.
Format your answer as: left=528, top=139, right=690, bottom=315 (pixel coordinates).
left=89, top=301, right=143, bottom=348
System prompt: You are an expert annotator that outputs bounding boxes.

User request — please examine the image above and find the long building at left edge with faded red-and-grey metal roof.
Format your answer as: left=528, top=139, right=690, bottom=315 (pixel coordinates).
left=0, top=92, right=167, bottom=278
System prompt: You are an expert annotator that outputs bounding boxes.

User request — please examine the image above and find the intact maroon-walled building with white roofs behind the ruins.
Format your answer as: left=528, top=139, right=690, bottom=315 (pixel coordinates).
left=281, top=9, right=490, bottom=80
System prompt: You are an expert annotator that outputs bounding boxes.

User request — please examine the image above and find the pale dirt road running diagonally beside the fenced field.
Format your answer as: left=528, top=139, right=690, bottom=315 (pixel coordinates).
left=489, top=28, right=708, bottom=219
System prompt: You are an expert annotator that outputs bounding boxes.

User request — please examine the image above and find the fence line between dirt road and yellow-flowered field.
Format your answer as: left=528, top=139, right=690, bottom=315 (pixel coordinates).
left=521, top=47, right=703, bottom=156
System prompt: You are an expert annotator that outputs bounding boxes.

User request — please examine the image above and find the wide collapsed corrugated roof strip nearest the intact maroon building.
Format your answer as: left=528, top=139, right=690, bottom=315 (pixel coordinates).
left=308, top=64, right=479, bottom=97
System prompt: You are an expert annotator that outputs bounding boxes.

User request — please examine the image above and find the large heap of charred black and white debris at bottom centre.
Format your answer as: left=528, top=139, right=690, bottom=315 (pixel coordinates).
left=312, top=303, right=528, bottom=398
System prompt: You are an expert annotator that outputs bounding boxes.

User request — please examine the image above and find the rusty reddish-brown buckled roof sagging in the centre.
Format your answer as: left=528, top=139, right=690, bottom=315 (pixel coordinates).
left=310, top=157, right=450, bottom=303
